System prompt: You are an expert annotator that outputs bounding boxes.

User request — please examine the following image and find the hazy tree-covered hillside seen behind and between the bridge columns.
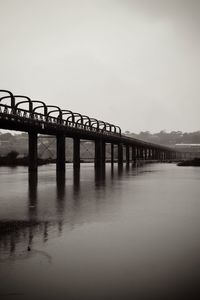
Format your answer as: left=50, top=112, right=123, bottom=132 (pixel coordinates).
left=0, top=130, right=200, bottom=160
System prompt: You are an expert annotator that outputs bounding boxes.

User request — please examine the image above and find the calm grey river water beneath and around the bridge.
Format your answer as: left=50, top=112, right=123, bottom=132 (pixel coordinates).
left=0, top=164, right=200, bottom=300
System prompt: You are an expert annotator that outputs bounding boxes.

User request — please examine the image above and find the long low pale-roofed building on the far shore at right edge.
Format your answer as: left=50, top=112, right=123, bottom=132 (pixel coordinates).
left=175, top=144, right=200, bottom=159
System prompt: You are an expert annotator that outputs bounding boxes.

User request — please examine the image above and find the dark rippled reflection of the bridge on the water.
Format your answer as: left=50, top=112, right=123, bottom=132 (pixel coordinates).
left=0, top=167, right=130, bottom=257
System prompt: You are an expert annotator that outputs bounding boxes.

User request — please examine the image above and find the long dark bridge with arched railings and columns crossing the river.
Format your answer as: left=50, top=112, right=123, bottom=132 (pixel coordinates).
left=0, top=90, right=177, bottom=172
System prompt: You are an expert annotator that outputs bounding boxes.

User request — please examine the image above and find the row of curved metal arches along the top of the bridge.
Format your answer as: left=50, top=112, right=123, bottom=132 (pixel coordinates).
left=0, top=90, right=121, bottom=136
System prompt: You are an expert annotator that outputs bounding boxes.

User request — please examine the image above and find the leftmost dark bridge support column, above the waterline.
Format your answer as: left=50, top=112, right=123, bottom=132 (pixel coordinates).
left=28, top=132, right=37, bottom=172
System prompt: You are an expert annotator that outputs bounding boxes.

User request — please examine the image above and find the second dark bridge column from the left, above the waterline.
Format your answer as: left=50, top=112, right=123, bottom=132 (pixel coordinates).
left=56, top=134, right=65, bottom=171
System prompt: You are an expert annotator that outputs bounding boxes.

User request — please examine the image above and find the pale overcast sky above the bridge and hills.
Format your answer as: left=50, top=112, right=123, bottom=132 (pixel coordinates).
left=0, top=0, right=200, bottom=133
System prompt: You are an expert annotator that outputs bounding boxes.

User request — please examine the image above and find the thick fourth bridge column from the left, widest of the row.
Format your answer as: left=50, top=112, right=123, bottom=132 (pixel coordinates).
left=95, top=139, right=106, bottom=171
